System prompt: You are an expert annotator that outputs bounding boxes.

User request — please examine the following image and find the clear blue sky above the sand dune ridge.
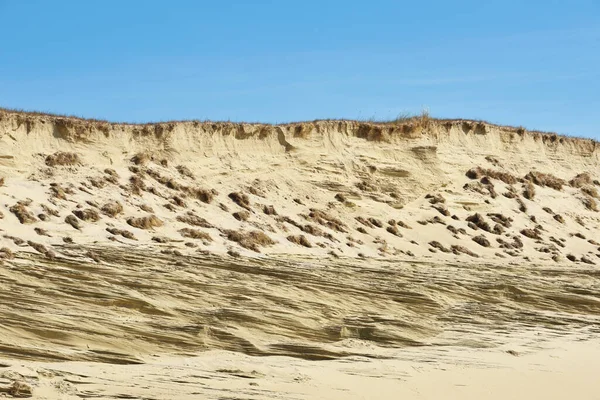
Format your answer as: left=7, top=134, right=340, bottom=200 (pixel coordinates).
left=0, top=0, right=600, bottom=138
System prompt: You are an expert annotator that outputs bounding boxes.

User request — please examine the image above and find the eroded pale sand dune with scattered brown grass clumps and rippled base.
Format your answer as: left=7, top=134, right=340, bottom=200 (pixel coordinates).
left=0, top=111, right=600, bottom=399
